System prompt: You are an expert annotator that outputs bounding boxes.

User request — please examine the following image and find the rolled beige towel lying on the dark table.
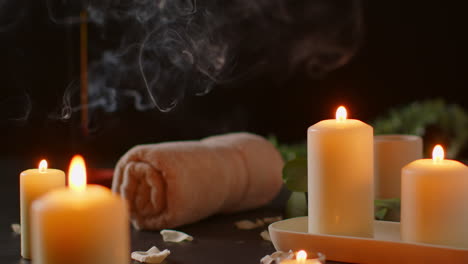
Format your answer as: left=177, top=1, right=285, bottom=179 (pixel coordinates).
left=112, top=133, right=283, bottom=230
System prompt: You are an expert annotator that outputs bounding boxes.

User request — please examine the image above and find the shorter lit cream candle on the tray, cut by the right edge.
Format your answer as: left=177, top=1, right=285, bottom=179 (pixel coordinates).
left=401, top=145, right=468, bottom=248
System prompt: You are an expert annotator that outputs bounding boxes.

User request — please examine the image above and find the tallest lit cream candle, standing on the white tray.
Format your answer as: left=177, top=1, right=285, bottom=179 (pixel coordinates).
left=307, top=107, right=374, bottom=237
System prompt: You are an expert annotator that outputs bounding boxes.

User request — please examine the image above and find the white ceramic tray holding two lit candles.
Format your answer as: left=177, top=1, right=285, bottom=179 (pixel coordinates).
left=268, top=216, right=468, bottom=264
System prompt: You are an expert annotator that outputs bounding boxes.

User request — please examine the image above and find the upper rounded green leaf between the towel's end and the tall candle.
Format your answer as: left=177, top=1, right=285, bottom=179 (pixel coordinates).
left=283, top=158, right=307, bottom=192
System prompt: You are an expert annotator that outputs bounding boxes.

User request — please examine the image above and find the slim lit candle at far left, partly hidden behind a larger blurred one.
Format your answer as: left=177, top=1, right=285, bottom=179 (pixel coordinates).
left=20, top=160, right=65, bottom=259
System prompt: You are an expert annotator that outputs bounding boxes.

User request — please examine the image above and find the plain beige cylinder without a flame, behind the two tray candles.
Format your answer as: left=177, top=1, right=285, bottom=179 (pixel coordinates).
left=374, top=135, right=423, bottom=199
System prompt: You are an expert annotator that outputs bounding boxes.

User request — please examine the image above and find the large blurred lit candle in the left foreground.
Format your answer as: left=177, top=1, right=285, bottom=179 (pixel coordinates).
left=31, top=156, right=130, bottom=264
